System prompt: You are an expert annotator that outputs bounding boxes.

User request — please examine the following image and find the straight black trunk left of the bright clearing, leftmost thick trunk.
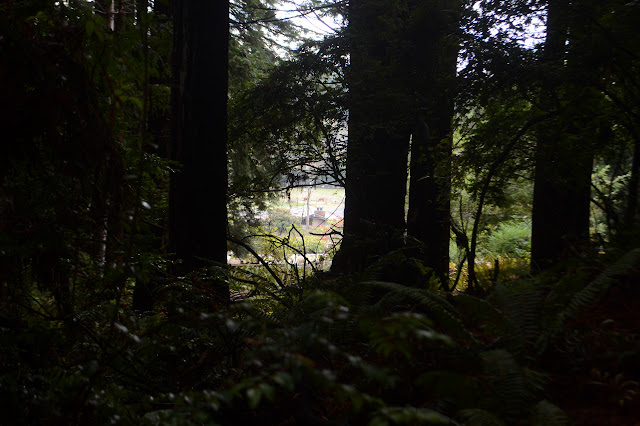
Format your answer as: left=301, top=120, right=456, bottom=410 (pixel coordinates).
left=169, top=0, right=229, bottom=302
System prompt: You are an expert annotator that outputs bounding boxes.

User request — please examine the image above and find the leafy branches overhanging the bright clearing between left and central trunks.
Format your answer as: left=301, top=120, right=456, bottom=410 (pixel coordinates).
left=229, top=33, right=346, bottom=208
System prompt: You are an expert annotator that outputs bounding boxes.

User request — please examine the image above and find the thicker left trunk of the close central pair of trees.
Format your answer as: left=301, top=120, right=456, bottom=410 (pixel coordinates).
left=333, top=0, right=410, bottom=272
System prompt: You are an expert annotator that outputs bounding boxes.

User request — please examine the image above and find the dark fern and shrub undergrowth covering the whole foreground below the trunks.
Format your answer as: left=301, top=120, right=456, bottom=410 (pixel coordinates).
left=0, top=249, right=640, bottom=425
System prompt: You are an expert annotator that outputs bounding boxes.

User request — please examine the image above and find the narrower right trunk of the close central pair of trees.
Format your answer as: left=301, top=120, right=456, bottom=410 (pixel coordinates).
left=407, top=0, right=461, bottom=289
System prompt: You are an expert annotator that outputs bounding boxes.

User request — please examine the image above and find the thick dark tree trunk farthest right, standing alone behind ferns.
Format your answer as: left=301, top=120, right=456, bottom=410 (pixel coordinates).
left=531, top=0, right=594, bottom=273
